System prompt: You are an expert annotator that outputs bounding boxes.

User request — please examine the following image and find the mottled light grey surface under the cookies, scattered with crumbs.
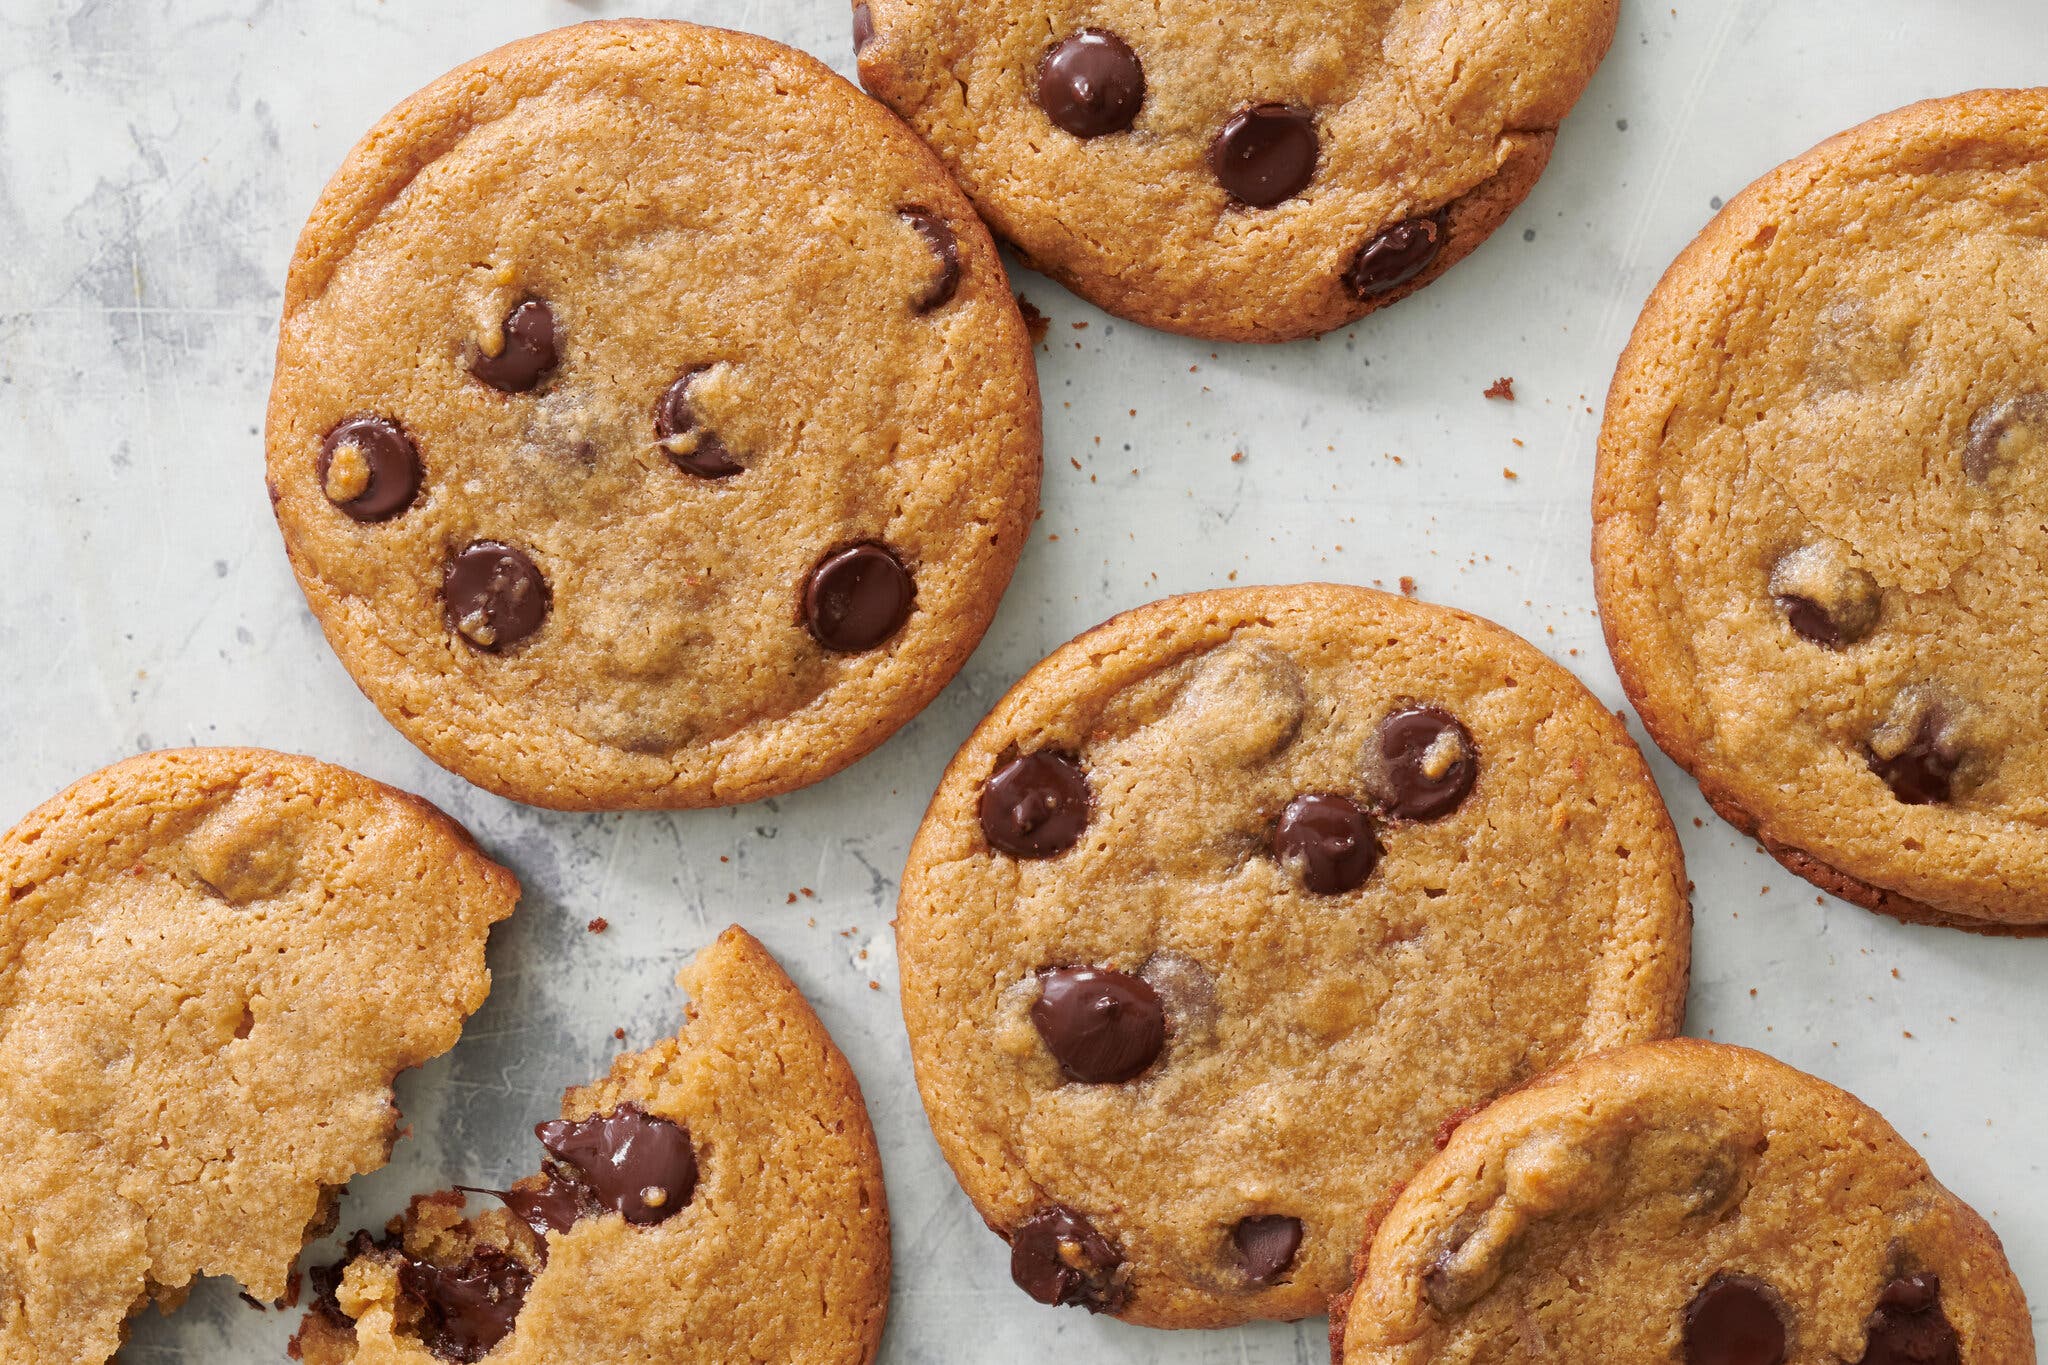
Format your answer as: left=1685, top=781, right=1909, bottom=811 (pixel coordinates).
left=0, top=0, right=2048, bottom=1365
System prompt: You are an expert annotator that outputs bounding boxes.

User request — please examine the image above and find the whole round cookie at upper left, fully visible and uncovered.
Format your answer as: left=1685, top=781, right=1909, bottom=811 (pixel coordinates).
left=266, top=20, right=1038, bottom=808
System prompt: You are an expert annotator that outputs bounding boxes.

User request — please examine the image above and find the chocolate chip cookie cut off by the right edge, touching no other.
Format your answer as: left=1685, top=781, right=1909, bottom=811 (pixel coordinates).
left=1593, top=90, right=2048, bottom=931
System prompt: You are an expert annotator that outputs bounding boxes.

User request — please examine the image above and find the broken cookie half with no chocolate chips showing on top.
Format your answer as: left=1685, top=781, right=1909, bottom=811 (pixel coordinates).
left=0, top=749, right=518, bottom=1365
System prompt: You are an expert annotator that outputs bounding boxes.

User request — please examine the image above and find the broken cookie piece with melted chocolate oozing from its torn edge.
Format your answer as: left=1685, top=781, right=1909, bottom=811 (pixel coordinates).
left=297, top=927, right=889, bottom=1365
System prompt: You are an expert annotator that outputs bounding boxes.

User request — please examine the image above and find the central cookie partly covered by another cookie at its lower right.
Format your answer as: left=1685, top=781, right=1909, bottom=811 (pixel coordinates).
left=897, top=585, right=1690, bottom=1326
